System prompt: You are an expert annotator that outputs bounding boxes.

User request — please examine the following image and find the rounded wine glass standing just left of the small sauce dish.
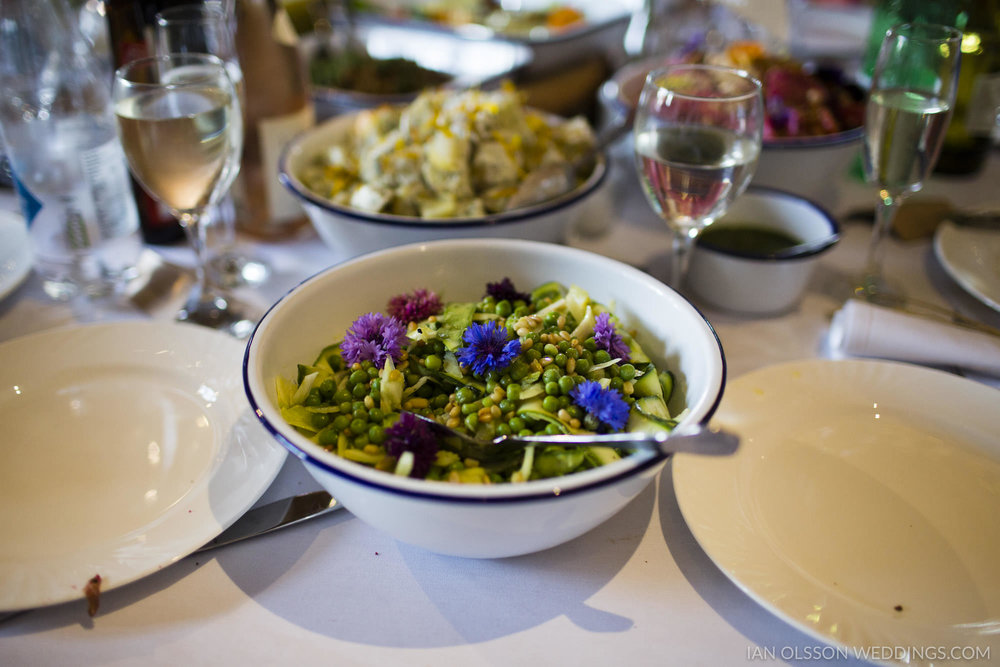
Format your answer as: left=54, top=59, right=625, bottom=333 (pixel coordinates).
left=633, top=64, right=764, bottom=290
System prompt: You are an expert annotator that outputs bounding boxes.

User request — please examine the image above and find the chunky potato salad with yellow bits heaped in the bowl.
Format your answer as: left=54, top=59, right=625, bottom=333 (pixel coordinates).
left=298, top=85, right=595, bottom=218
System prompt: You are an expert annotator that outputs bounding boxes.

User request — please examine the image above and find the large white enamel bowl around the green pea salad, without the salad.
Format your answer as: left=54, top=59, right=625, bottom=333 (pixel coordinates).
left=244, top=239, right=725, bottom=558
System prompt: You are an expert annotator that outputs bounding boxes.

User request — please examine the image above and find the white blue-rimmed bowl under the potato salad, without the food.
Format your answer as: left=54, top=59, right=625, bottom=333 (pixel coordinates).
left=278, top=113, right=607, bottom=258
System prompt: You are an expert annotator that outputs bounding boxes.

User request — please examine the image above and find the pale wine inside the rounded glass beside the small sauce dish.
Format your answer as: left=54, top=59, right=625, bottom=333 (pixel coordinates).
left=635, top=125, right=760, bottom=229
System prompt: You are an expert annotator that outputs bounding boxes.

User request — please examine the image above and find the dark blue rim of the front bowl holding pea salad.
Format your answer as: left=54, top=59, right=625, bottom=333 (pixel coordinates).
left=243, top=239, right=728, bottom=505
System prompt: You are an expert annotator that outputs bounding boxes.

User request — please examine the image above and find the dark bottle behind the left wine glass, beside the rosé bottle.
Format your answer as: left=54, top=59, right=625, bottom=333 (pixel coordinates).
left=104, top=0, right=184, bottom=245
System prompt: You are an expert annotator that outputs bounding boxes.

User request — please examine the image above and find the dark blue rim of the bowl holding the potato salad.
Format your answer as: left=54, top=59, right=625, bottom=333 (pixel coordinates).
left=278, top=122, right=608, bottom=230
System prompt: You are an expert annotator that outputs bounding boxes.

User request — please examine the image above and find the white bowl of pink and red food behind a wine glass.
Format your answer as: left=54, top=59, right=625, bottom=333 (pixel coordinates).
left=599, top=44, right=865, bottom=207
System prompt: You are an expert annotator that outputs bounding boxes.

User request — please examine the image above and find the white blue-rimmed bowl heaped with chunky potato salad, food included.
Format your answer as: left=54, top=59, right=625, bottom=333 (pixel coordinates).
left=279, top=85, right=607, bottom=258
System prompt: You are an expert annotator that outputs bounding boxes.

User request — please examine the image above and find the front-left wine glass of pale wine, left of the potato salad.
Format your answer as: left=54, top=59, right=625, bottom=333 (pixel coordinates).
left=112, top=53, right=256, bottom=338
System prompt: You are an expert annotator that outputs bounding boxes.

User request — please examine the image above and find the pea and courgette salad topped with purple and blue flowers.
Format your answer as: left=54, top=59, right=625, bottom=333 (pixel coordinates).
left=275, top=278, right=676, bottom=483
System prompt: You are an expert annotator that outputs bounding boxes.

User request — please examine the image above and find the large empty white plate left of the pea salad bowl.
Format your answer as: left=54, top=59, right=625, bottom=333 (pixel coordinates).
left=0, top=321, right=285, bottom=611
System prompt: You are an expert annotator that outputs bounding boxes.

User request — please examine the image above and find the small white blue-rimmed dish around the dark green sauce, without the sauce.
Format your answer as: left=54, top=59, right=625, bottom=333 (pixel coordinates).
left=687, top=187, right=840, bottom=315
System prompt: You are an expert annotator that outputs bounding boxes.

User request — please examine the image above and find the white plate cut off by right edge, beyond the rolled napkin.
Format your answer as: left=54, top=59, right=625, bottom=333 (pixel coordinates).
left=934, top=222, right=1000, bottom=310
